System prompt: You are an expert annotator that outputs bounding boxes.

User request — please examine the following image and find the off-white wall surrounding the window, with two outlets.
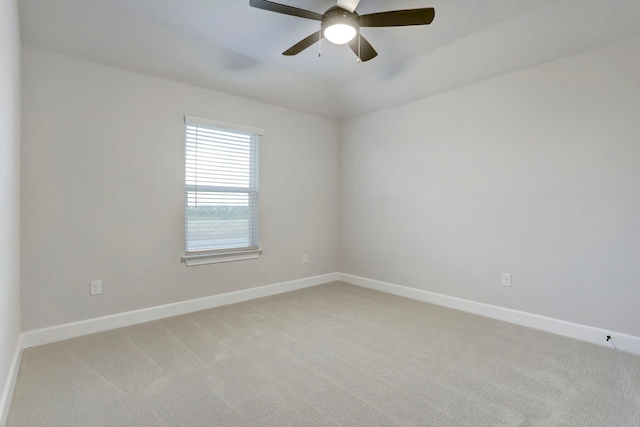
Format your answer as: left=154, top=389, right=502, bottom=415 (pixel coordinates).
left=22, top=48, right=339, bottom=331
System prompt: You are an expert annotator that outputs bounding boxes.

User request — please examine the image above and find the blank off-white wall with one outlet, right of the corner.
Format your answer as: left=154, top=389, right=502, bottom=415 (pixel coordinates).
left=339, top=38, right=640, bottom=336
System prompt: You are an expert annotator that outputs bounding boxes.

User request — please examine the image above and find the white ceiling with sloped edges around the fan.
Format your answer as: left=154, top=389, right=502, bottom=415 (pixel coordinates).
left=18, top=0, right=640, bottom=119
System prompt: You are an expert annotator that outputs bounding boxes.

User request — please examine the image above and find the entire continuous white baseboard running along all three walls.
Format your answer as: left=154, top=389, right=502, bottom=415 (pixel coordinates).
left=5, top=273, right=640, bottom=426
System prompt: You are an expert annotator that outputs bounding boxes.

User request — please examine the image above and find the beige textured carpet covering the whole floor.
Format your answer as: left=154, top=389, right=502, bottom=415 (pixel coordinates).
left=7, top=283, right=640, bottom=427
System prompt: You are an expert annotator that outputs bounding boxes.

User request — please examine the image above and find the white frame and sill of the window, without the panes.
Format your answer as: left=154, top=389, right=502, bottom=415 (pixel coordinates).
left=182, top=115, right=264, bottom=267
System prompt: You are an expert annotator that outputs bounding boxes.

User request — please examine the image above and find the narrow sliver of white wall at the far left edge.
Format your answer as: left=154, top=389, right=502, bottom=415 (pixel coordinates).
left=0, top=0, right=20, bottom=423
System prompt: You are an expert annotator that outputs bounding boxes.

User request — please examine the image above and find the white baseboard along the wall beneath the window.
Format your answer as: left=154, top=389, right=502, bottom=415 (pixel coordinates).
left=21, top=273, right=338, bottom=348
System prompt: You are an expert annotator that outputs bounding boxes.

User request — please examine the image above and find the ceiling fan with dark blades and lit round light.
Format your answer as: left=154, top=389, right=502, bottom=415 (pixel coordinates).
left=249, top=0, right=436, bottom=62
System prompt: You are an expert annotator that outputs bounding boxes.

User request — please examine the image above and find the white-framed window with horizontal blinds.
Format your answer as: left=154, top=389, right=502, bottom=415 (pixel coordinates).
left=184, top=116, right=264, bottom=266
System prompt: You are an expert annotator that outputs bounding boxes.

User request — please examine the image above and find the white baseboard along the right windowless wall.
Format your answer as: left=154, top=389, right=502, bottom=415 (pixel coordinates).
left=338, top=273, right=640, bottom=355
